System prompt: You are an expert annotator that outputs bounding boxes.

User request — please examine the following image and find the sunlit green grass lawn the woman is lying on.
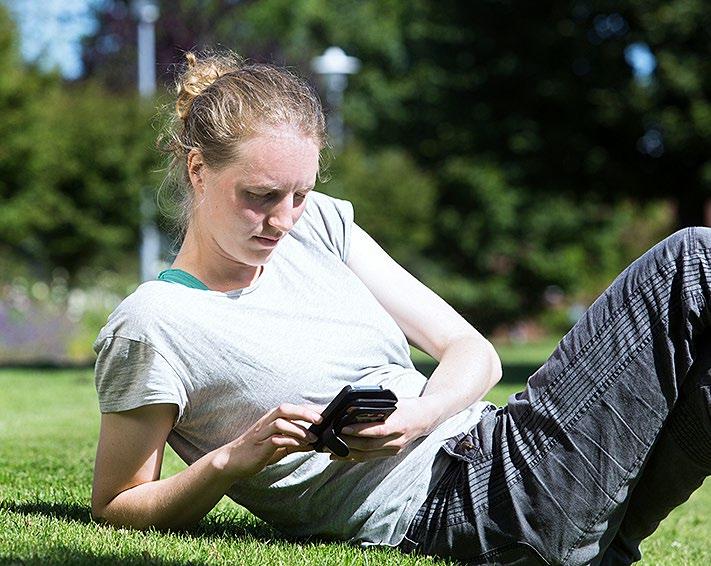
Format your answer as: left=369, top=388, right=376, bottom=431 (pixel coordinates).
left=0, top=348, right=711, bottom=566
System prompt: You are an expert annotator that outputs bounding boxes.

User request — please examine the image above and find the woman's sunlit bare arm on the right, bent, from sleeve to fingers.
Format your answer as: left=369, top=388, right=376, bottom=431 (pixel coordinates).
left=347, top=225, right=501, bottom=456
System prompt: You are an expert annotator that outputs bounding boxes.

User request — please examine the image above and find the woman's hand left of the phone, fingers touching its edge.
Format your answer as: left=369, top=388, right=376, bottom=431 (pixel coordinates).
left=224, top=403, right=321, bottom=479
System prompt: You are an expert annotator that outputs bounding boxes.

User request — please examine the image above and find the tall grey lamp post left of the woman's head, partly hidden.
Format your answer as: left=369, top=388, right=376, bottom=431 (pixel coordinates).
left=132, top=0, right=160, bottom=281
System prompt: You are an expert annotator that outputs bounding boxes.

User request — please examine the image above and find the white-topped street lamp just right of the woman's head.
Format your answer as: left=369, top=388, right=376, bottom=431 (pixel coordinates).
left=311, top=47, right=360, bottom=149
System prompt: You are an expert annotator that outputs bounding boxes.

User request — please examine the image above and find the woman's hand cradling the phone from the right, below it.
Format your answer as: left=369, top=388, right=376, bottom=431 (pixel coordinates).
left=331, top=396, right=437, bottom=462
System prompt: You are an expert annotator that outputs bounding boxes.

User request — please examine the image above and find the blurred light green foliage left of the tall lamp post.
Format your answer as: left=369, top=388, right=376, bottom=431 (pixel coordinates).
left=0, top=3, right=155, bottom=278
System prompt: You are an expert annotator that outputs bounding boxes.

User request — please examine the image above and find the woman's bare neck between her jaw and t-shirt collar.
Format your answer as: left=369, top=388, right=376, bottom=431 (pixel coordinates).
left=171, top=229, right=263, bottom=291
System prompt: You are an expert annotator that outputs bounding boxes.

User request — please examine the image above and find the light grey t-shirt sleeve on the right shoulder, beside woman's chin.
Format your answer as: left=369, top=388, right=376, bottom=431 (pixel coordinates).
left=301, top=191, right=353, bottom=262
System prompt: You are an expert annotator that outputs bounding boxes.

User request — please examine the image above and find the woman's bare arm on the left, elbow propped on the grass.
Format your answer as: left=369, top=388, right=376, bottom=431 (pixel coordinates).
left=91, top=404, right=321, bottom=529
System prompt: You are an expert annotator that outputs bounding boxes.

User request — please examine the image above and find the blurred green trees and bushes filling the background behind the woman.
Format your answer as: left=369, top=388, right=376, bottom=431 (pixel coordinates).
left=0, top=0, right=711, bottom=359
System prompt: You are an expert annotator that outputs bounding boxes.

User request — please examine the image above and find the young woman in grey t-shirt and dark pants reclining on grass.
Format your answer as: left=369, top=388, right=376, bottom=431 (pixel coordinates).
left=92, top=54, right=711, bottom=564
